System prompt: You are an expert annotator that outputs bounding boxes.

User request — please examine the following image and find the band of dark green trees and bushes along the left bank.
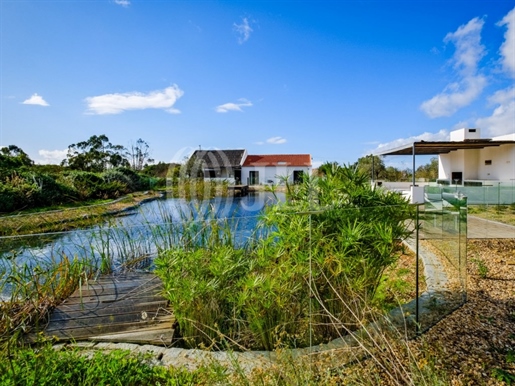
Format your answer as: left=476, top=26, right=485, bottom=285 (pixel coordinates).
left=0, top=135, right=175, bottom=213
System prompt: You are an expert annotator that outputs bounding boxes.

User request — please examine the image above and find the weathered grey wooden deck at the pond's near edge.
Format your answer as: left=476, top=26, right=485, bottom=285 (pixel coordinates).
left=45, top=273, right=174, bottom=345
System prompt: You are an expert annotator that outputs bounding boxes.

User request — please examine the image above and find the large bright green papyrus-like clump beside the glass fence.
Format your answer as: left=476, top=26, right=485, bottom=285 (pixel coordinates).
left=156, top=167, right=412, bottom=350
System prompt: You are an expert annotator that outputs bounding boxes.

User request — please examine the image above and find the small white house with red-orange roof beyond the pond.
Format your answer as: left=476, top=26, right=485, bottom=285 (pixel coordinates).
left=241, top=154, right=312, bottom=185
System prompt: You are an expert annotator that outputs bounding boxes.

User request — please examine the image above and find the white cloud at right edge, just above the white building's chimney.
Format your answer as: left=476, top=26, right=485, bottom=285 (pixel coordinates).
left=476, top=86, right=515, bottom=137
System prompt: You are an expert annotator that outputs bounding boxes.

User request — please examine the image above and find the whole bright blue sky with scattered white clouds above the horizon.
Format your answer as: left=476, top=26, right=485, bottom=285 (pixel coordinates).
left=0, top=0, right=515, bottom=167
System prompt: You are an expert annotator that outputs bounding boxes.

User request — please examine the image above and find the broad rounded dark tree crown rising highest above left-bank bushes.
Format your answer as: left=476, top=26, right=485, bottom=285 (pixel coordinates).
left=61, top=134, right=130, bottom=172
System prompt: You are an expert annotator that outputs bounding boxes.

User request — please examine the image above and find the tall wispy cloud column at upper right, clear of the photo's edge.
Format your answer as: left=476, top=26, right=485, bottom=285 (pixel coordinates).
left=420, top=17, right=487, bottom=118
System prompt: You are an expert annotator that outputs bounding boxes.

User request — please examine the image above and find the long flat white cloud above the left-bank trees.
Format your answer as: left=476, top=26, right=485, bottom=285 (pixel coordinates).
left=85, top=85, right=184, bottom=115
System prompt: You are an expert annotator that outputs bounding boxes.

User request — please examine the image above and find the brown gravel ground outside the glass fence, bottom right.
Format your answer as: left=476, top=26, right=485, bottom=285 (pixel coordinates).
left=412, top=239, right=515, bottom=385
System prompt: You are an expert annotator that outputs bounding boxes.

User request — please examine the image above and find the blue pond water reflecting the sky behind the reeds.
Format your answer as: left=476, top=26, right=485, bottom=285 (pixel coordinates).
left=0, top=192, right=284, bottom=292
